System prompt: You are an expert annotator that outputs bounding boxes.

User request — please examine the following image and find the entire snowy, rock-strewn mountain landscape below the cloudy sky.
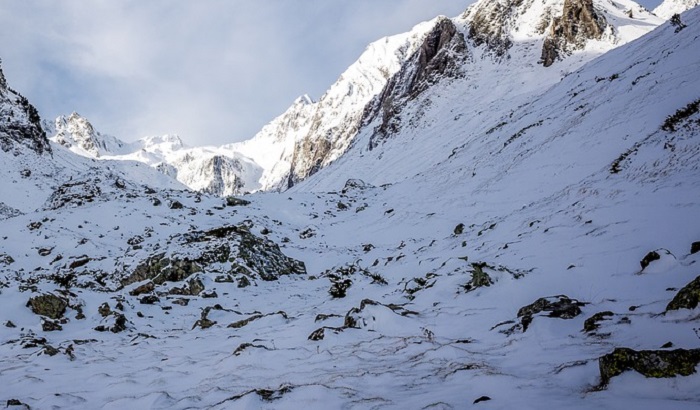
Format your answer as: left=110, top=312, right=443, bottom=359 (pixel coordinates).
left=0, top=0, right=700, bottom=409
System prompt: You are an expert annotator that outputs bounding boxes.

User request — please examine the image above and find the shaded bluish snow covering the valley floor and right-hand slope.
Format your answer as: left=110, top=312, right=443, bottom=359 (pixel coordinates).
left=0, top=1, right=700, bottom=409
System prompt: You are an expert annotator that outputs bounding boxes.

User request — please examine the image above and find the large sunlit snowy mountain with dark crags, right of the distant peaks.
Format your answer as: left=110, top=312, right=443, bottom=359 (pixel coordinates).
left=254, top=0, right=662, bottom=189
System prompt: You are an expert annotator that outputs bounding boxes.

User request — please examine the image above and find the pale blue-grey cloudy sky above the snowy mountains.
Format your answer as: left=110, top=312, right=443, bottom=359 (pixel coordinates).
left=0, top=0, right=659, bottom=145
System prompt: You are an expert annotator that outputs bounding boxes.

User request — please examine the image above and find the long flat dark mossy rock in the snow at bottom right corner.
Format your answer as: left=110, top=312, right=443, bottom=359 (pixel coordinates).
left=598, top=347, right=700, bottom=386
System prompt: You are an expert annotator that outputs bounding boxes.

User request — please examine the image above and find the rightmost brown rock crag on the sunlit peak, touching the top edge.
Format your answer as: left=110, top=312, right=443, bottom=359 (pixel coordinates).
left=542, top=0, right=609, bottom=67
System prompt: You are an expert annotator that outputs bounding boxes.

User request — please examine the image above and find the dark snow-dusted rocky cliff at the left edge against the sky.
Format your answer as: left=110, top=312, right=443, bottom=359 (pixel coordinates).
left=0, top=61, right=51, bottom=154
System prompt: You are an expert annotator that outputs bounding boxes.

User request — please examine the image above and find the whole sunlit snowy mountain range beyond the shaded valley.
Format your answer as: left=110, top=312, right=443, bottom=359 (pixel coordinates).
left=38, top=0, right=693, bottom=196
